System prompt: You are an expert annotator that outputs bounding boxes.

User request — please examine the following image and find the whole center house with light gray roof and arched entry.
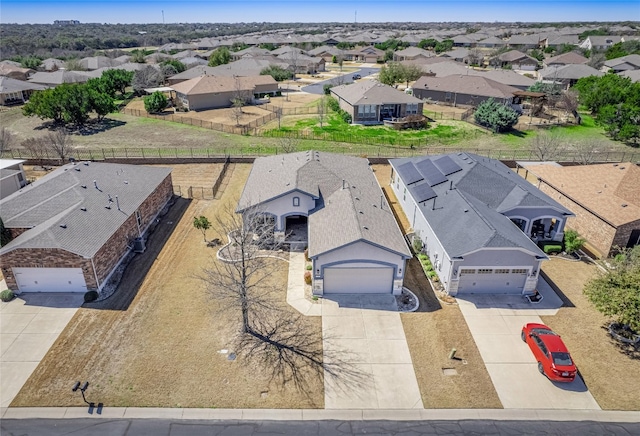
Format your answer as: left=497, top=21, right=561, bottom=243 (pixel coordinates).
left=236, top=151, right=412, bottom=295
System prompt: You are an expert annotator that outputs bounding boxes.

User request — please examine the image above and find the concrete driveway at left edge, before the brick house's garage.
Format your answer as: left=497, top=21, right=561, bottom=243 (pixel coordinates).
left=0, top=293, right=84, bottom=407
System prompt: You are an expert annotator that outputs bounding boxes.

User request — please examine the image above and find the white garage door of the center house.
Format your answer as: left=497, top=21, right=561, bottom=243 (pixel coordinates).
left=324, top=267, right=393, bottom=294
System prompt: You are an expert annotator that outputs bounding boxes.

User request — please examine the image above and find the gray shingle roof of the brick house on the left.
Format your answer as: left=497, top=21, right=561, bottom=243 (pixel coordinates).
left=0, top=162, right=171, bottom=258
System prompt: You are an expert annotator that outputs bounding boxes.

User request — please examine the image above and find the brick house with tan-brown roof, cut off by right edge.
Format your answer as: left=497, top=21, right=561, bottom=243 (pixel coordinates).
left=527, top=162, right=640, bottom=257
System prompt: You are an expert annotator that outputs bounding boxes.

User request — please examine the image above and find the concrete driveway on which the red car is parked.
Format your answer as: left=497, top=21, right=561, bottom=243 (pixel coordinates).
left=458, top=279, right=600, bottom=410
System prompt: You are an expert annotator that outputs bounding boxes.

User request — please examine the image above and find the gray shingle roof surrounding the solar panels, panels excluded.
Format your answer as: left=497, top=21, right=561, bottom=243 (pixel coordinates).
left=389, top=153, right=571, bottom=257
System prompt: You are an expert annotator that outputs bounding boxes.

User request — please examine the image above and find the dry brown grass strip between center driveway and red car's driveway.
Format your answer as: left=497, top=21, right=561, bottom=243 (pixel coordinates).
left=373, top=165, right=502, bottom=409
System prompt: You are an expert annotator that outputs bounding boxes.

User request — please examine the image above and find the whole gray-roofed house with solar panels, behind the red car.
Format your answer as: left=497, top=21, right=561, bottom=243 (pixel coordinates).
left=389, top=153, right=574, bottom=295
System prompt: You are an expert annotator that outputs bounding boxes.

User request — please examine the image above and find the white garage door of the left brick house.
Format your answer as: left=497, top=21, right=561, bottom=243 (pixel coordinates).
left=13, top=268, right=87, bottom=292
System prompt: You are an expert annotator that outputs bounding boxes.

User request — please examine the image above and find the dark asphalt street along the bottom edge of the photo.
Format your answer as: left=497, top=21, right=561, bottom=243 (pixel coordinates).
left=0, top=418, right=640, bottom=436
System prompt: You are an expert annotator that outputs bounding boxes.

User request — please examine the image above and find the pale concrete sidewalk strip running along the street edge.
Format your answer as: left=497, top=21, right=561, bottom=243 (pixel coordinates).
left=0, top=407, right=640, bottom=423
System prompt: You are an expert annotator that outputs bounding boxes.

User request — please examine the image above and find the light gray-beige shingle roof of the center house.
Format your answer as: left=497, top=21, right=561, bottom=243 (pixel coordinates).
left=238, top=151, right=411, bottom=257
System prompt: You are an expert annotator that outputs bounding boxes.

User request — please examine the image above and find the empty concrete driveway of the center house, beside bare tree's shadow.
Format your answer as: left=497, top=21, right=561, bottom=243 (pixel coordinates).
left=322, top=295, right=423, bottom=409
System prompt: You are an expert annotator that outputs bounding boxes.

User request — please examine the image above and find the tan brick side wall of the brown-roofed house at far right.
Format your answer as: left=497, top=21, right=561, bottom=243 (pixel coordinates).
left=539, top=180, right=620, bottom=257
